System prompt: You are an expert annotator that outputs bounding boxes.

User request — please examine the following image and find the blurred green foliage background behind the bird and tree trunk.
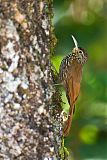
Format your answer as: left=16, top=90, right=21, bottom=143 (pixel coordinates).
left=53, top=0, right=107, bottom=160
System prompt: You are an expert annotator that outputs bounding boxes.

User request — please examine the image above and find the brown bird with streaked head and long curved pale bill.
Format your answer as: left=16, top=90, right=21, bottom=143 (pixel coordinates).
left=59, top=35, right=88, bottom=137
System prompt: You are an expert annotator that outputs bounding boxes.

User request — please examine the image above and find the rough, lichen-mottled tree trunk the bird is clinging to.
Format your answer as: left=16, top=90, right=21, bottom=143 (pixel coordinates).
left=0, top=0, right=62, bottom=160
